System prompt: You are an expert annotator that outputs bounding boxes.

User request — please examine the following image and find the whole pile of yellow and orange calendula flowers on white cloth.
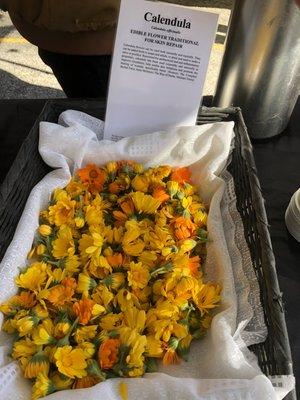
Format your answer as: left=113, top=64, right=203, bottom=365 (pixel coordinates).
left=0, top=161, right=221, bottom=399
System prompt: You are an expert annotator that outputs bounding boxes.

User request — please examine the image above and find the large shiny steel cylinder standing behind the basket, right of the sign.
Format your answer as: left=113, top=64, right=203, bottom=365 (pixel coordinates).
left=214, top=0, right=300, bottom=138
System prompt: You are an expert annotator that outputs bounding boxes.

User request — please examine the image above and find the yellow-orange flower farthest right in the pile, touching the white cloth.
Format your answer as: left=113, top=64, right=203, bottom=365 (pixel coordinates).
left=193, top=283, right=221, bottom=315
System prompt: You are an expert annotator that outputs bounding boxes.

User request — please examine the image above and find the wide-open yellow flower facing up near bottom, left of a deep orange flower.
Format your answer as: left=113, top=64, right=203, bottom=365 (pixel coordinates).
left=54, top=346, right=87, bottom=378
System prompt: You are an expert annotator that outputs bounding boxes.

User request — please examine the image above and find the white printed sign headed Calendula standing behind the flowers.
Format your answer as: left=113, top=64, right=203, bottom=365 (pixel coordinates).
left=104, top=0, right=218, bottom=140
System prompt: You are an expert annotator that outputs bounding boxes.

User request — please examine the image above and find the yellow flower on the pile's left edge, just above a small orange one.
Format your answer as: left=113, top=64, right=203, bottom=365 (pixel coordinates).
left=15, top=262, right=47, bottom=291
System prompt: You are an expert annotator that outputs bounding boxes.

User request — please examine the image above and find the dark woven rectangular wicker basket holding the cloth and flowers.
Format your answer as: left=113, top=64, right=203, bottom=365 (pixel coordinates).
left=0, top=100, right=296, bottom=400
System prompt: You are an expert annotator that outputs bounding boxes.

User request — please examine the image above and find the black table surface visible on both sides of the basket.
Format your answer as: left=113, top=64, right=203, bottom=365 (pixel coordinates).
left=0, top=99, right=300, bottom=398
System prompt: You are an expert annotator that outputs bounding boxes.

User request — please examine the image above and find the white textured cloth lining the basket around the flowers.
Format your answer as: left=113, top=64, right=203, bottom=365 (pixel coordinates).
left=0, top=110, right=294, bottom=400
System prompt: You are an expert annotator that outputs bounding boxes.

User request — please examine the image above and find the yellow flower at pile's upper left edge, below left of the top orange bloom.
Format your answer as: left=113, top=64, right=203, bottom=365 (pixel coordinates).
left=49, top=196, right=76, bottom=226
